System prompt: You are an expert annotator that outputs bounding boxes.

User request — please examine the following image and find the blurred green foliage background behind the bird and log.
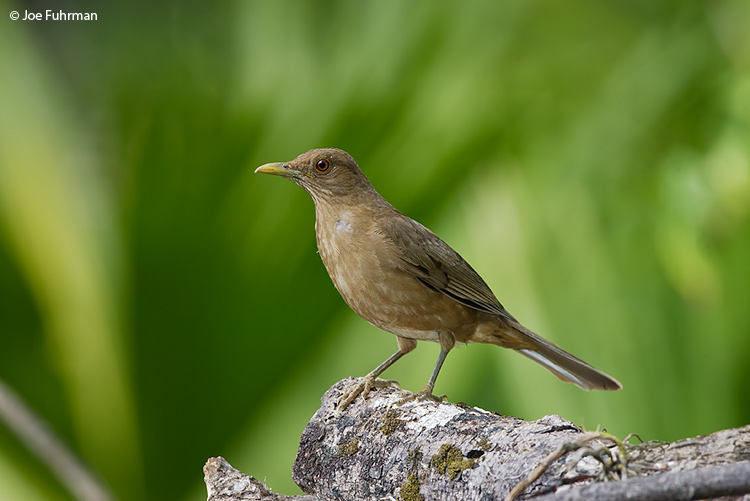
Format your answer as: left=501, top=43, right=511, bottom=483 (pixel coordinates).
left=0, top=0, right=750, bottom=500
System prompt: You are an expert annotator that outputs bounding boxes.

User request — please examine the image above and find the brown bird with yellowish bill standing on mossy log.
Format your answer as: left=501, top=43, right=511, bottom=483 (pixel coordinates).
left=255, top=148, right=622, bottom=410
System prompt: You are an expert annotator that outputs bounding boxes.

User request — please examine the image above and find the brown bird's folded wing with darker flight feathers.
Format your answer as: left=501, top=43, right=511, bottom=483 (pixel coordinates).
left=378, top=213, right=515, bottom=320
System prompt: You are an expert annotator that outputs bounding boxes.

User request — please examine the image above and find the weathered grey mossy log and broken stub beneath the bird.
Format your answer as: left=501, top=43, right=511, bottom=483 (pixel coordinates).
left=205, top=378, right=750, bottom=501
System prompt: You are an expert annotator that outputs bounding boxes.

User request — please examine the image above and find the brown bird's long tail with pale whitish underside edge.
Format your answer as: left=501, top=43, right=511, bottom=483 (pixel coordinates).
left=516, top=328, right=622, bottom=390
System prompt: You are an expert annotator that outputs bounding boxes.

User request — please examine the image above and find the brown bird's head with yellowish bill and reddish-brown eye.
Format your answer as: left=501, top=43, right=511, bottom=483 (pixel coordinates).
left=255, top=148, right=375, bottom=203
